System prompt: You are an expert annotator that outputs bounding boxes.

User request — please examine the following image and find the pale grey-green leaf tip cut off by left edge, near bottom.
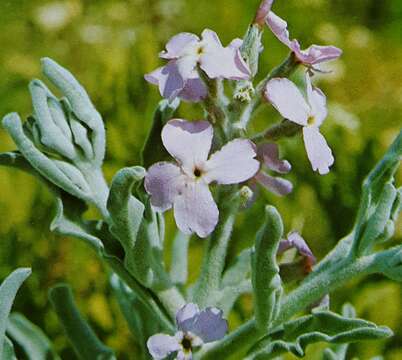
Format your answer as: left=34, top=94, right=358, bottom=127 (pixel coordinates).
left=0, top=268, right=31, bottom=354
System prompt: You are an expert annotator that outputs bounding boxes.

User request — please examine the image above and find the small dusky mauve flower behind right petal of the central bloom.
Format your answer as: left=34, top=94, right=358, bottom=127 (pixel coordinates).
left=254, top=143, right=293, bottom=196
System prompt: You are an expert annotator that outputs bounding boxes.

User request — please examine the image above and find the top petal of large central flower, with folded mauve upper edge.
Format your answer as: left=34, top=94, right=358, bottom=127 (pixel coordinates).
left=162, top=119, right=213, bottom=173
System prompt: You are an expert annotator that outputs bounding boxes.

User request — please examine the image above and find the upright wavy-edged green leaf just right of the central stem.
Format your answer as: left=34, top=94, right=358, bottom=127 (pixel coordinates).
left=252, top=206, right=283, bottom=331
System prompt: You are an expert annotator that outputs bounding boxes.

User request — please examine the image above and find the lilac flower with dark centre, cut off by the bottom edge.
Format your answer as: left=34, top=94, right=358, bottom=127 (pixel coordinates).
left=147, top=303, right=228, bottom=360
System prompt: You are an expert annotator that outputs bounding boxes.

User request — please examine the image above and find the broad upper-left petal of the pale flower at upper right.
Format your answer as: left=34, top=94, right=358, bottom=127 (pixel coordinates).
left=265, top=78, right=310, bottom=125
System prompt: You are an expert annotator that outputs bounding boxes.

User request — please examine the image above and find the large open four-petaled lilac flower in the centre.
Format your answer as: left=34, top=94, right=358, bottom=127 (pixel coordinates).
left=145, top=119, right=260, bottom=237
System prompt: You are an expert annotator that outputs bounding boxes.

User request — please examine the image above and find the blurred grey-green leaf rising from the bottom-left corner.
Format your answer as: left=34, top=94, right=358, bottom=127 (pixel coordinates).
left=7, top=313, right=60, bottom=360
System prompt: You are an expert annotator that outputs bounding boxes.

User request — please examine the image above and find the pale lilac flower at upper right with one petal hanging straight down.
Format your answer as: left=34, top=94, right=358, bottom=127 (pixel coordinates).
left=265, top=72, right=334, bottom=175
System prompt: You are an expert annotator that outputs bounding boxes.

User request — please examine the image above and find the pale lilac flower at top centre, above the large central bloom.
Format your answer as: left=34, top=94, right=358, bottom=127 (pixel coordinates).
left=145, top=29, right=250, bottom=101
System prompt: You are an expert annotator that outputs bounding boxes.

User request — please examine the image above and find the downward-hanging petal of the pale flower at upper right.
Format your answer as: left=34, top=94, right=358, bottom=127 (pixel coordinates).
left=303, top=126, right=334, bottom=175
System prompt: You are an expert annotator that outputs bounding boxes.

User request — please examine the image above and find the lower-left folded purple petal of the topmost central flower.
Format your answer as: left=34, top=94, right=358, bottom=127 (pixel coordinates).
left=144, top=60, right=185, bottom=100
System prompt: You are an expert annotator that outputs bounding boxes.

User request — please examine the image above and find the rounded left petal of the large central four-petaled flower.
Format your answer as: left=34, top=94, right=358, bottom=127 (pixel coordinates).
left=144, top=162, right=184, bottom=211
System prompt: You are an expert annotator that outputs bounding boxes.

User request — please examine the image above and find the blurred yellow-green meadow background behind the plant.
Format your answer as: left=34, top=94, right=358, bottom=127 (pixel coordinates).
left=0, top=0, right=402, bottom=360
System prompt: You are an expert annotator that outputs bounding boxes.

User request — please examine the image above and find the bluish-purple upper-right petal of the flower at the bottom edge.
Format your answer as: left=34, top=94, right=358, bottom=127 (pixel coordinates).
left=190, top=308, right=228, bottom=343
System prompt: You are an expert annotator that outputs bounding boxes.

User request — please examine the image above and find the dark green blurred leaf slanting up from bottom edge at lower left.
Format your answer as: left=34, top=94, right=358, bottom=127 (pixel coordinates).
left=49, top=284, right=116, bottom=360
